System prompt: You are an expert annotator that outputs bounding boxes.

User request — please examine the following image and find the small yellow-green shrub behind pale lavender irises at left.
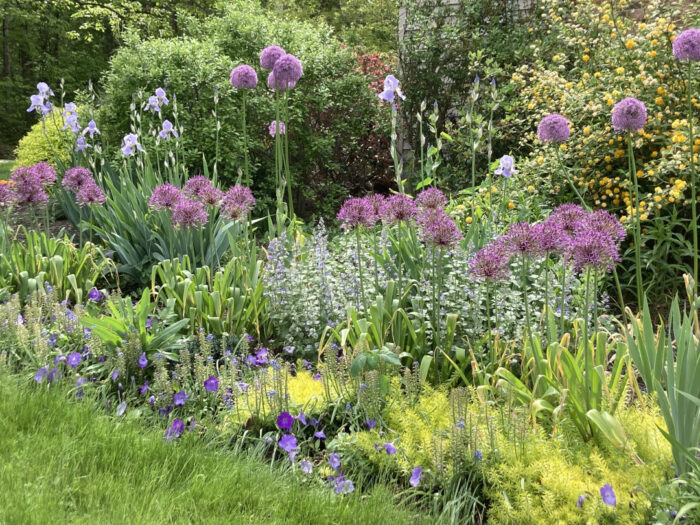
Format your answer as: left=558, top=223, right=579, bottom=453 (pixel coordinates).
left=13, top=109, right=73, bottom=169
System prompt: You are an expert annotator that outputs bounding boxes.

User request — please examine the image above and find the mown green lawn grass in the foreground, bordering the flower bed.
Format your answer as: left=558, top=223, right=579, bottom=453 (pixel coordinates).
left=0, top=375, right=429, bottom=525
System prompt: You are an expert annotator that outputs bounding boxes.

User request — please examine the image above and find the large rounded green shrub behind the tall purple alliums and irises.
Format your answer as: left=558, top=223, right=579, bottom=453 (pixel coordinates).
left=98, top=0, right=388, bottom=215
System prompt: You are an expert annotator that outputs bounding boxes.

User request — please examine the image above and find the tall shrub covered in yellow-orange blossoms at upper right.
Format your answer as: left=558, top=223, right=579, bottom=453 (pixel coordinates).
left=511, top=0, right=700, bottom=220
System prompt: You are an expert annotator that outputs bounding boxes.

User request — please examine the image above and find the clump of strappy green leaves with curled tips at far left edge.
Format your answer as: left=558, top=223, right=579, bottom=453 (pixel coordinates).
left=0, top=230, right=117, bottom=304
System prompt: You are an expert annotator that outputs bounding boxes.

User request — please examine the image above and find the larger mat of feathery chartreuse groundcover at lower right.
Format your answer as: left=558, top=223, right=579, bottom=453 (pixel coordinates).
left=347, top=381, right=672, bottom=525
